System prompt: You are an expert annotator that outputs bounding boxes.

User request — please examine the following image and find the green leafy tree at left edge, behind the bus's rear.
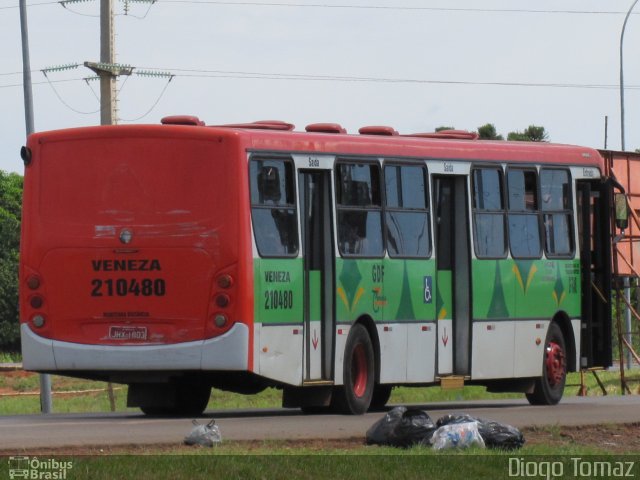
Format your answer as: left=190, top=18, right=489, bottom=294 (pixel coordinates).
left=0, top=170, right=23, bottom=351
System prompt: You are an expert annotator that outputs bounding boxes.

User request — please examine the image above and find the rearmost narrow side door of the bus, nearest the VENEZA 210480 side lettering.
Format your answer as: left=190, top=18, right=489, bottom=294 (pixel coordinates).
left=298, top=170, right=335, bottom=384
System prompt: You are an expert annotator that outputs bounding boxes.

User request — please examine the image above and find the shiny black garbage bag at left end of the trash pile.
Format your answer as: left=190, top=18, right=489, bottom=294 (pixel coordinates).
left=367, top=407, right=436, bottom=448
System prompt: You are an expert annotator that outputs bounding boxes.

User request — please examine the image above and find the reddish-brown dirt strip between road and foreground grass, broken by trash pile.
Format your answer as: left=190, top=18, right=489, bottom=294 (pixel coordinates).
left=5, top=423, right=640, bottom=455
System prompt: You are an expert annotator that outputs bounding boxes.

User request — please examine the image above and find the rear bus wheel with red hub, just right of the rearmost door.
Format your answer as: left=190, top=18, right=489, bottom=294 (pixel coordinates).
left=332, top=324, right=375, bottom=415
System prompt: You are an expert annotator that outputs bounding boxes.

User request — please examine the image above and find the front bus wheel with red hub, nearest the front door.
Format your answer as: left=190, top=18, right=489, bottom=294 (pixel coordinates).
left=527, top=322, right=567, bottom=405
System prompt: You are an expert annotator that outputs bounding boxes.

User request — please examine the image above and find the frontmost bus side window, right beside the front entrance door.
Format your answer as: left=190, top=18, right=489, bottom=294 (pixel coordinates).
left=540, top=168, right=574, bottom=257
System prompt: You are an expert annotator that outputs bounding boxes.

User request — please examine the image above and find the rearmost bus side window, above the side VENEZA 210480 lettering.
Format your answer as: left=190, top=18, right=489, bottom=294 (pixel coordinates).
left=249, top=158, right=298, bottom=257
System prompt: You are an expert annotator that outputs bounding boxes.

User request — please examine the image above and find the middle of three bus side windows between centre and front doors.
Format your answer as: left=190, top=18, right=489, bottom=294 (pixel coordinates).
left=507, top=169, right=542, bottom=258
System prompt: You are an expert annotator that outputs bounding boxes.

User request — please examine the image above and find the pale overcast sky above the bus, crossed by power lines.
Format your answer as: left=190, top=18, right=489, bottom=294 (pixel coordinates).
left=0, top=0, right=640, bottom=173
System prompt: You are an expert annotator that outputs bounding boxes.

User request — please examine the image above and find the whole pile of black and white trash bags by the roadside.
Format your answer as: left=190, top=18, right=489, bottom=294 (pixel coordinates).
left=367, top=407, right=524, bottom=450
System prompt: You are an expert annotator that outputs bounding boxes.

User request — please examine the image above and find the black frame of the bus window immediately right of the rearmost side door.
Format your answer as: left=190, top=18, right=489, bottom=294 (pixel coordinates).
left=333, top=156, right=387, bottom=259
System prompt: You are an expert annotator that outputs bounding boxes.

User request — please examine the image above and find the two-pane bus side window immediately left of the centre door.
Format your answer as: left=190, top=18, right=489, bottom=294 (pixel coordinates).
left=384, top=165, right=431, bottom=258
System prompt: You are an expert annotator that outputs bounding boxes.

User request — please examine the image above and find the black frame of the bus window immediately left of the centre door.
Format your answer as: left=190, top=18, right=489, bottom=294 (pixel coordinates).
left=382, top=158, right=434, bottom=260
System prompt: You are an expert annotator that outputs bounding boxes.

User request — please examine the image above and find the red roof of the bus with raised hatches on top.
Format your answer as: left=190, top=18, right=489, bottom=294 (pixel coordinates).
left=26, top=120, right=604, bottom=174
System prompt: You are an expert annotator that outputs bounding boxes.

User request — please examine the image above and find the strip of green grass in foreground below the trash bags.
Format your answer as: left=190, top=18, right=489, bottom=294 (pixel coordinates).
left=0, top=442, right=638, bottom=480
